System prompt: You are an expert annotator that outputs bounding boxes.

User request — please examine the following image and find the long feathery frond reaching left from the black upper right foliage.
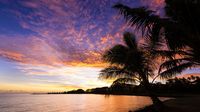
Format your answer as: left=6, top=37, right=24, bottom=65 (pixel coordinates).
left=113, top=4, right=170, bottom=48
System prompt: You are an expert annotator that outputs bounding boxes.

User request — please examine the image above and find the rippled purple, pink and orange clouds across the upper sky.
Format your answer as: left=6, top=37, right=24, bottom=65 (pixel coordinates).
left=0, top=0, right=165, bottom=66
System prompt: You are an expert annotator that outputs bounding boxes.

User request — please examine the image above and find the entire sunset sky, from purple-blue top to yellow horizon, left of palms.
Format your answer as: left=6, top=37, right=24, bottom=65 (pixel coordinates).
left=0, top=0, right=198, bottom=92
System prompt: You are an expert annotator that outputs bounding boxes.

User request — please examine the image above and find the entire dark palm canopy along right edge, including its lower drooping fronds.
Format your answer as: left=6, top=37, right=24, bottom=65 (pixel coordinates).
left=114, top=0, right=200, bottom=81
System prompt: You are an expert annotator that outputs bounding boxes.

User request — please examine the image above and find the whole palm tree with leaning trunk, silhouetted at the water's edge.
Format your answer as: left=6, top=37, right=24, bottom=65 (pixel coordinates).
left=100, top=32, right=162, bottom=106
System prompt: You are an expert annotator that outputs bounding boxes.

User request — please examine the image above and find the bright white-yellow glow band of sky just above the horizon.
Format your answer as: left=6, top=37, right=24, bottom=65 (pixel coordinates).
left=0, top=61, right=111, bottom=92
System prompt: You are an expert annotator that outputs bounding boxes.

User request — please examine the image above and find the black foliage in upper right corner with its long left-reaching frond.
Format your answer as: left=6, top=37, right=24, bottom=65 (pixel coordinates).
left=113, top=0, right=200, bottom=49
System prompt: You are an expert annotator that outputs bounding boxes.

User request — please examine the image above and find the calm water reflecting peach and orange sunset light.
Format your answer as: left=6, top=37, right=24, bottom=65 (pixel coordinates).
left=0, top=94, right=166, bottom=112
